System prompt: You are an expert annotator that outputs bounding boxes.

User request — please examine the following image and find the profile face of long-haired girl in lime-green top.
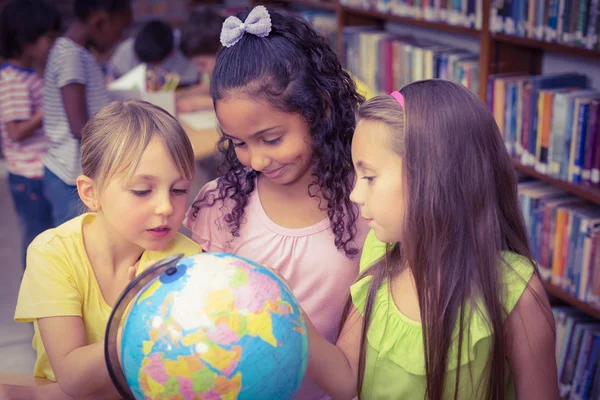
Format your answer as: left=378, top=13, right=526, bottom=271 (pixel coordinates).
left=350, top=120, right=406, bottom=243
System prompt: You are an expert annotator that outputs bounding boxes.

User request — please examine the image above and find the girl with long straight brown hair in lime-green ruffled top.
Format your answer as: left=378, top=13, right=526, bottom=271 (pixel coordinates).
left=307, top=80, right=558, bottom=400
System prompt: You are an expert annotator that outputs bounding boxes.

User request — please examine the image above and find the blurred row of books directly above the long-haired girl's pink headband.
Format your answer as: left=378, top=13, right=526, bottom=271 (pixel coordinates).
left=343, top=27, right=479, bottom=93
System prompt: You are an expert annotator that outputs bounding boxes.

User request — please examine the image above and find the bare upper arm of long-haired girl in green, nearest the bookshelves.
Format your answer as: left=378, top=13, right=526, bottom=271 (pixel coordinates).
left=506, top=275, right=560, bottom=400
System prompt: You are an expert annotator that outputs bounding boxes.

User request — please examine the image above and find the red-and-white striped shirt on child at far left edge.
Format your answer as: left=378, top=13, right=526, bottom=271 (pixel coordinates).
left=0, top=64, right=48, bottom=179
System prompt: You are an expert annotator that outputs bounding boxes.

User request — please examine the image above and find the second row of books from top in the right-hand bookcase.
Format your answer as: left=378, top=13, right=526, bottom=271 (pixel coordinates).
left=487, top=73, right=600, bottom=185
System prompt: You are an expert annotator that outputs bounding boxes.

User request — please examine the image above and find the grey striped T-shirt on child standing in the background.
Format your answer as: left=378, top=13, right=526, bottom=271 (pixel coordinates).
left=44, top=37, right=110, bottom=185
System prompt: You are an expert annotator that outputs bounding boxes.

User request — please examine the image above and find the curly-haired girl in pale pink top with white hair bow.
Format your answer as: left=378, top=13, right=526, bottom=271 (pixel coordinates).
left=184, top=6, right=367, bottom=400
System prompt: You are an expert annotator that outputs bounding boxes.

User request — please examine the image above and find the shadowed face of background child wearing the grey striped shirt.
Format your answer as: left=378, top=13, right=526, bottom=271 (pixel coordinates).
left=88, top=11, right=132, bottom=53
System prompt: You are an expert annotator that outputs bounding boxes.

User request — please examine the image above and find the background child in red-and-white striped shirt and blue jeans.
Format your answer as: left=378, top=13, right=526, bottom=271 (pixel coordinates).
left=0, top=0, right=60, bottom=265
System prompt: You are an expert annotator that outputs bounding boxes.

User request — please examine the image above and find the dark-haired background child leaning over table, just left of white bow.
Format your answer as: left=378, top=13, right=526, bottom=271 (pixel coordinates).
left=177, top=7, right=225, bottom=112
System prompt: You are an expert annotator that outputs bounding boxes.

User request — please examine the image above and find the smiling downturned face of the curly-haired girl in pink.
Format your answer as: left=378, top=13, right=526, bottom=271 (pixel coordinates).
left=215, top=94, right=313, bottom=185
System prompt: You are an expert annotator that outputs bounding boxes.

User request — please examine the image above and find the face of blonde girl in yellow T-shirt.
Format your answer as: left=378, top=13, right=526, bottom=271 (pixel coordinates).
left=98, top=137, right=191, bottom=251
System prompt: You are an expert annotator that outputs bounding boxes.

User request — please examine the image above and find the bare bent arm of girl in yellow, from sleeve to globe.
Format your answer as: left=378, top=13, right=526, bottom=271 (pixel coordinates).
left=38, top=317, right=119, bottom=399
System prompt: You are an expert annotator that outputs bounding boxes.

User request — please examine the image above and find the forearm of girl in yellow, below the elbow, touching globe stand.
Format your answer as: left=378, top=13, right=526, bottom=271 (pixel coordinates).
left=58, top=341, right=119, bottom=399
